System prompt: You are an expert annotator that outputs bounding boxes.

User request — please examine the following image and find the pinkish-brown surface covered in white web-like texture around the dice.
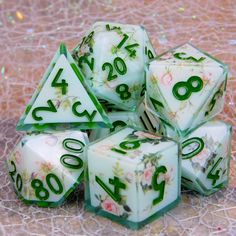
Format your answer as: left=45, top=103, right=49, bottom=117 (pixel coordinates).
left=0, top=0, right=236, bottom=236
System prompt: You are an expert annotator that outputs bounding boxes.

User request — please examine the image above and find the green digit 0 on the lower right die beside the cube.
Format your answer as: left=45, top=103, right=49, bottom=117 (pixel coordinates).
left=182, top=137, right=204, bottom=160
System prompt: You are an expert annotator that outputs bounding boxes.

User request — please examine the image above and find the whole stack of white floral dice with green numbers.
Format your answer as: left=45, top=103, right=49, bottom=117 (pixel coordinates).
left=7, top=22, right=231, bottom=229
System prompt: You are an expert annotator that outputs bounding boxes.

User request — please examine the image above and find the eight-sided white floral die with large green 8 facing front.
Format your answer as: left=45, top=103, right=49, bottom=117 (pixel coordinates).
left=146, top=44, right=228, bottom=134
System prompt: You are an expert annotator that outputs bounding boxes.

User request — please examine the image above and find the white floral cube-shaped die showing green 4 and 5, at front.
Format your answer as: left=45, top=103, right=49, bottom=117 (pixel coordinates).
left=85, top=127, right=180, bottom=229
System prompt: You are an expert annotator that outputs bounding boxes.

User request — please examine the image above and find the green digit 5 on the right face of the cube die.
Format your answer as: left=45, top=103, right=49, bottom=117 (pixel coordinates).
left=152, top=166, right=167, bottom=205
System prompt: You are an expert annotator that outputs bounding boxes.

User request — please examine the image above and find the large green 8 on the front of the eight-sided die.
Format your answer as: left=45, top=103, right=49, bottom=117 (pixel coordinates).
left=172, top=76, right=203, bottom=101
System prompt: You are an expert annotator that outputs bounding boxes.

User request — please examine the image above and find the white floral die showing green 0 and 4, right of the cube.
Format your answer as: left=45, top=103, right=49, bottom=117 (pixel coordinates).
left=182, top=121, right=231, bottom=195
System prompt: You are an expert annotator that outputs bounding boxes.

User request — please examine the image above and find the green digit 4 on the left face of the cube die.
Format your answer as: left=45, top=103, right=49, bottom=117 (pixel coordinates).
left=95, top=176, right=126, bottom=203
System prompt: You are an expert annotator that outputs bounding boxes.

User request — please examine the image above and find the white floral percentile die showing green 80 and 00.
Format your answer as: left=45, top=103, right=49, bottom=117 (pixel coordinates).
left=7, top=131, right=88, bottom=207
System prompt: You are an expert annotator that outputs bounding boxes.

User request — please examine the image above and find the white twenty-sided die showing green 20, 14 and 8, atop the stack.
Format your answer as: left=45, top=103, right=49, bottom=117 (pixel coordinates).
left=73, top=22, right=155, bottom=110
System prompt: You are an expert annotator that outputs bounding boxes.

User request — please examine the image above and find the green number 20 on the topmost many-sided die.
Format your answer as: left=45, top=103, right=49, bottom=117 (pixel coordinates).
left=102, top=57, right=127, bottom=81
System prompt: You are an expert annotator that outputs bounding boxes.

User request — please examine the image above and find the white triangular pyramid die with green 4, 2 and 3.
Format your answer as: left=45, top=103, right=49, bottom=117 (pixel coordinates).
left=17, top=44, right=111, bottom=131
